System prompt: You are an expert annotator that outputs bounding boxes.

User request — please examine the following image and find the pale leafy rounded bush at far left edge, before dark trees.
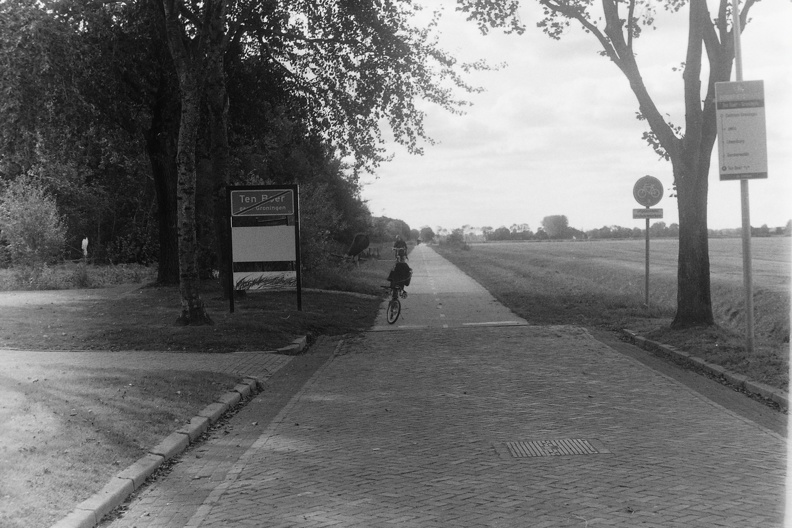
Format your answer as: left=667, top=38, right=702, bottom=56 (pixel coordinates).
left=0, top=176, right=66, bottom=268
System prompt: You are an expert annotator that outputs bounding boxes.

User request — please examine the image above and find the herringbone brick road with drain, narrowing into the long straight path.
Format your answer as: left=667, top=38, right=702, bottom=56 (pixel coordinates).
left=100, top=247, right=785, bottom=528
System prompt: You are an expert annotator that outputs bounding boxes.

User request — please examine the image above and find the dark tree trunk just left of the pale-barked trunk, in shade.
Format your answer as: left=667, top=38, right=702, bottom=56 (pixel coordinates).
left=145, top=72, right=179, bottom=284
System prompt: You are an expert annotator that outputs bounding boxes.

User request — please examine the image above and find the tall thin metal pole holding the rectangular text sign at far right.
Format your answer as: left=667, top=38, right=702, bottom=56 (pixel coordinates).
left=732, top=0, right=754, bottom=354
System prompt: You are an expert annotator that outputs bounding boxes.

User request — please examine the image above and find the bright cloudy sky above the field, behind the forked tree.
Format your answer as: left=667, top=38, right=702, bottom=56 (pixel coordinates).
left=362, top=0, right=792, bottom=231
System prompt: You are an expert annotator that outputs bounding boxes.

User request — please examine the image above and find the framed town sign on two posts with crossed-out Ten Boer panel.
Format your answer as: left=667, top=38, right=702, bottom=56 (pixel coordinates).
left=227, top=185, right=302, bottom=313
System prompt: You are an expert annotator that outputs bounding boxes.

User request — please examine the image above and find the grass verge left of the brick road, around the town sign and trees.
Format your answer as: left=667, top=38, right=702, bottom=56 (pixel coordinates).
left=0, top=261, right=392, bottom=528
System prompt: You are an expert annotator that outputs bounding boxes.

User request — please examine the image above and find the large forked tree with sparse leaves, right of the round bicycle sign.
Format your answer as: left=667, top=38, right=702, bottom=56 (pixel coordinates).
left=459, top=0, right=756, bottom=328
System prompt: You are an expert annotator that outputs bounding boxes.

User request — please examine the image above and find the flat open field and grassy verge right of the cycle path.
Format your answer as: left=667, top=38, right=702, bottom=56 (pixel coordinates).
left=441, top=238, right=792, bottom=390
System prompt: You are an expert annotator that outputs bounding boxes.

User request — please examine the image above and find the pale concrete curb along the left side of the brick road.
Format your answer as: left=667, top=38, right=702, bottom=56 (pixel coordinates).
left=52, top=376, right=262, bottom=528
